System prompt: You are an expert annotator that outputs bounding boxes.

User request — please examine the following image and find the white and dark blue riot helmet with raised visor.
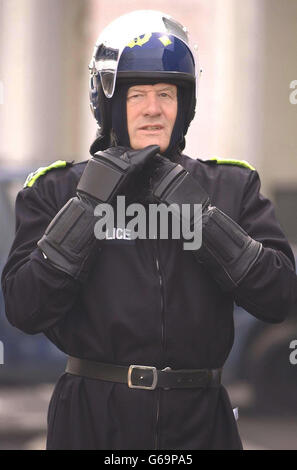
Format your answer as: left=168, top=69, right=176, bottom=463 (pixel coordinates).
left=89, top=10, right=196, bottom=153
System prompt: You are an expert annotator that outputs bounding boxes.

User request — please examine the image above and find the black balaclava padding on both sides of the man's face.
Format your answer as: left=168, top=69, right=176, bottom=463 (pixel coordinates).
left=111, top=83, right=188, bottom=161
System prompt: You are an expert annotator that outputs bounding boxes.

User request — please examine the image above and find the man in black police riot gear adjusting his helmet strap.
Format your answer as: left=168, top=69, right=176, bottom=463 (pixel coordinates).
left=2, top=11, right=297, bottom=449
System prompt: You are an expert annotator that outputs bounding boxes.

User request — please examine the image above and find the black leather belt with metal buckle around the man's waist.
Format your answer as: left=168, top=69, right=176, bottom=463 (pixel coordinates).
left=65, top=356, right=222, bottom=390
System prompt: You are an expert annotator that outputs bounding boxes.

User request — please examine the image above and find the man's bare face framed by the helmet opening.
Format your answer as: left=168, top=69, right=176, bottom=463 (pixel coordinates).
left=127, top=83, right=177, bottom=152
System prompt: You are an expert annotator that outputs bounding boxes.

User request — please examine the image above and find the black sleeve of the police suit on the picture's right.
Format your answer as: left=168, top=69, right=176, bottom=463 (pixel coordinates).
left=234, top=171, right=297, bottom=323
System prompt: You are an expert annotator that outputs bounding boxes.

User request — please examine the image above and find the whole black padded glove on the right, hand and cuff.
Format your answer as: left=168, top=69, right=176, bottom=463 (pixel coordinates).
left=150, top=156, right=262, bottom=292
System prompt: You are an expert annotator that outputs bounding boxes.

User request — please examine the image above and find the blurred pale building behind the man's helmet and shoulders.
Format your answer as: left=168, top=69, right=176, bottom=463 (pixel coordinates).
left=0, top=0, right=297, bottom=196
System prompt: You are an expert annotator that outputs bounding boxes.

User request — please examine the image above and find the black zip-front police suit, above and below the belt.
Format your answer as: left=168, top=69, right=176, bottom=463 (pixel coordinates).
left=2, top=155, right=297, bottom=449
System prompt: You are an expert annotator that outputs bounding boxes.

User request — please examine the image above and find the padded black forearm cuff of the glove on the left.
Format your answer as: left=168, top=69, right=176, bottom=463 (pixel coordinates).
left=37, top=197, right=96, bottom=278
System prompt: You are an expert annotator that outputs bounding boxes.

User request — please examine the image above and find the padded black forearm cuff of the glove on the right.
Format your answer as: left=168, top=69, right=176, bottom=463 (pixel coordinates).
left=195, top=207, right=262, bottom=291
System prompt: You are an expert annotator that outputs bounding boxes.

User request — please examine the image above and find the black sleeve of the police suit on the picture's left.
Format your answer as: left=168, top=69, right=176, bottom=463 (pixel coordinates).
left=2, top=179, right=79, bottom=334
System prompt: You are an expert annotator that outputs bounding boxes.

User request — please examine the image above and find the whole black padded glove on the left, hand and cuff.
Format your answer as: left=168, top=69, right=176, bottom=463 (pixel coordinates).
left=38, top=145, right=160, bottom=281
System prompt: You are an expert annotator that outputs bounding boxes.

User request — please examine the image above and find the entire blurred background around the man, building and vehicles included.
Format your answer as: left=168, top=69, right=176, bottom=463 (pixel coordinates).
left=0, top=0, right=297, bottom=449
